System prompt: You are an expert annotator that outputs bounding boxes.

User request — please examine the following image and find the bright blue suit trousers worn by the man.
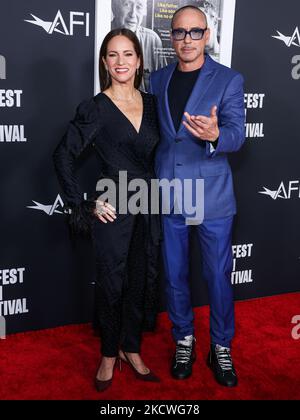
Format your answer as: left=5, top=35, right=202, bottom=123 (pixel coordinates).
left=162, top=214, right=234, bottom=347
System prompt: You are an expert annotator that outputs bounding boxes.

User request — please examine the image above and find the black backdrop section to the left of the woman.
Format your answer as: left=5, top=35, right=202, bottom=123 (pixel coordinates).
left=0, top=0, right=95, bottom=333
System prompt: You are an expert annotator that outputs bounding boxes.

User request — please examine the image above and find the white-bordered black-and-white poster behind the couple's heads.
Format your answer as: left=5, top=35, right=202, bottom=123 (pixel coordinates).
left=95, top=0, right=235, bottom=93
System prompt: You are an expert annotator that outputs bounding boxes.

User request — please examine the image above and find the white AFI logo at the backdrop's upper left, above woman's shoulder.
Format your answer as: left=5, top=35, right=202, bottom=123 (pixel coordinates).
left=24, top=10, right=90, bottom=36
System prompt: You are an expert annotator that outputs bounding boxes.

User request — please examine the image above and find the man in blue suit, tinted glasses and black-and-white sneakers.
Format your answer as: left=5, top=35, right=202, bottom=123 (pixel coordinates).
left=150, top=6, right=245, bottom=386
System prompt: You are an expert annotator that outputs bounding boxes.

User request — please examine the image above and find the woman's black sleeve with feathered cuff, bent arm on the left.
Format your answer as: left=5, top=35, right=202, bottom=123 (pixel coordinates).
left=53, top=99, right=100, bottom=234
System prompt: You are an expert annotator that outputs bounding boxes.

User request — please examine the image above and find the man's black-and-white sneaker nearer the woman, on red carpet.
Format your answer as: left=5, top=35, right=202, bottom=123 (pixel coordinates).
left=171, top=335, right=196, bottom=379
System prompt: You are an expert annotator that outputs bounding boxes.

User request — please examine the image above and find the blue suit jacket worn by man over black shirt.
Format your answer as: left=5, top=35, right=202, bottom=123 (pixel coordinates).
left=150, top=55, right=245, bottom=220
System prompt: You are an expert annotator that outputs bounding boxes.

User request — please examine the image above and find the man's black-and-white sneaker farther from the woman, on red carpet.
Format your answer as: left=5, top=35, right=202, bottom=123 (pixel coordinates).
left=207, top=344, right=238, bottom=387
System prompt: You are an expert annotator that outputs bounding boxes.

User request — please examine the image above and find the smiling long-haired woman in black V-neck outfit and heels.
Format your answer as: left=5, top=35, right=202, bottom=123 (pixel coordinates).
left=53, top=29, right=160, bottom=391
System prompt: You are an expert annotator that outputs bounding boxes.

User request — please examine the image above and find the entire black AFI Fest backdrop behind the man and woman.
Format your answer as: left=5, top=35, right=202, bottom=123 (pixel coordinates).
left=0, top=0, right=300, bottom=333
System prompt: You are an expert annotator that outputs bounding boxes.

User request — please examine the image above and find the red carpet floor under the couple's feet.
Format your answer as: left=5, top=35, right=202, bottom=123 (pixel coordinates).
left=0, top=293, right=300, bottom=400
